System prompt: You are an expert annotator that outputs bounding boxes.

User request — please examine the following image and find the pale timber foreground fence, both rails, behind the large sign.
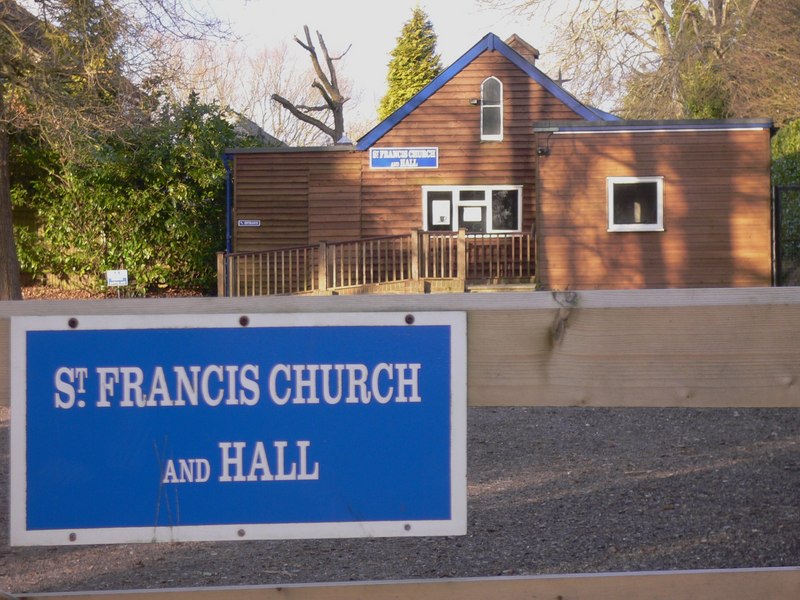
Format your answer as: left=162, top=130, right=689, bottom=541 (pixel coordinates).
left=0, top=288, right=800, bottom=600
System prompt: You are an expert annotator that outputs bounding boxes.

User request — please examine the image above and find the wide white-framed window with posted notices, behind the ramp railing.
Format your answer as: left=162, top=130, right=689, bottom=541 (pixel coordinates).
left=422, top=185, right=522, bottom=233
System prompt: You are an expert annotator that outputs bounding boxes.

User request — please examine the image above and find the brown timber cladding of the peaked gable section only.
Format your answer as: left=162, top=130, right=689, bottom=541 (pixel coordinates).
left=362, top=52, right=578, bottom=237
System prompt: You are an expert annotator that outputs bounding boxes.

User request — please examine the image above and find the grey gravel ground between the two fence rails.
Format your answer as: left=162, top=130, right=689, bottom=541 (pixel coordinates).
left=0, top=408, right=800, bottom=593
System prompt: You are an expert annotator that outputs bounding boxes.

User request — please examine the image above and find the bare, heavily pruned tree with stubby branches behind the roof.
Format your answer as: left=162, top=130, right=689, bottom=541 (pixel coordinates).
left=272, top=26, right=350, bottom=144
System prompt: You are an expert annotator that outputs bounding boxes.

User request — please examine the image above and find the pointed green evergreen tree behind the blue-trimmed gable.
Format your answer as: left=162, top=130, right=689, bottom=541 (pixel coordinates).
left=378, top=6, right=442, bottom=120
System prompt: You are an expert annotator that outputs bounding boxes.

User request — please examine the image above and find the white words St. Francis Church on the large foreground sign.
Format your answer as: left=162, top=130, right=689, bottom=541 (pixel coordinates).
left=53, top=362, right=422, bottom=410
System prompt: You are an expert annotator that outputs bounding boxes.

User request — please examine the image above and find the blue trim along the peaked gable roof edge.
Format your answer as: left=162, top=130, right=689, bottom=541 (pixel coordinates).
left=356, top=33, right=617, bottom=150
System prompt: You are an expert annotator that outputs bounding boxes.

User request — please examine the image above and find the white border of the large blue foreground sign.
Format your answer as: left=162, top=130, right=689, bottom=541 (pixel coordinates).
left=9, top=311, right=467, bottom=546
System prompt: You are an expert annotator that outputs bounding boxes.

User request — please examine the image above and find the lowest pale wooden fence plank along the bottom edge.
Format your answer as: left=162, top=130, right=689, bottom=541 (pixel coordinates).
left=17, top=567, right=800, bottom=600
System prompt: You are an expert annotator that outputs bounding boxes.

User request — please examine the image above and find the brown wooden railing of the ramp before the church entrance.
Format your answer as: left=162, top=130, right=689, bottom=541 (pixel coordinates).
left=217, top=230, right=535, bottom=296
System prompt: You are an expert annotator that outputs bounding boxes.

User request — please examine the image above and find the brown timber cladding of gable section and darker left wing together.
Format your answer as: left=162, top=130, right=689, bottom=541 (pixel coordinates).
left=228, top=52, right=579, bottom=252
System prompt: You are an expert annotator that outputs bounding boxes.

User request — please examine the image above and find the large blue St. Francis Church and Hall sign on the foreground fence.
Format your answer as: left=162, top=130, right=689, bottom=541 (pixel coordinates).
left=11, top=312, right=466, bottom=545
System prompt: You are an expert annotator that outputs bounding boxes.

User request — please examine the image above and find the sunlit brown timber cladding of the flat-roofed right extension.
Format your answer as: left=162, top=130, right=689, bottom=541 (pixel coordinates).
left=537, top=129, right=772, bottom=289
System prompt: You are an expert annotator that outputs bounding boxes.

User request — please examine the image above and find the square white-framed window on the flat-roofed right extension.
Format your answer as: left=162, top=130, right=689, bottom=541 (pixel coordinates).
left=606, top=177, right=664, bottom=231
